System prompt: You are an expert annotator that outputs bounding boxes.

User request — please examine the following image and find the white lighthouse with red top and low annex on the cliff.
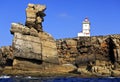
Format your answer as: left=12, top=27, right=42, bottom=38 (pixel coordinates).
left=78, top=18, right=90, bottom=37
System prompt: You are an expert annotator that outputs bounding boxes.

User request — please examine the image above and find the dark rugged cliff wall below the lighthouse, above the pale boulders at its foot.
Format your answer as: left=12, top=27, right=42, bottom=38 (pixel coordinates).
left=56, top=35, right=120, bottom=65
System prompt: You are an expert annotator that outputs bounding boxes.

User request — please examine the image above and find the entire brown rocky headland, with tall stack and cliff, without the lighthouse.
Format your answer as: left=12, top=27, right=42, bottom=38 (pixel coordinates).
left=0, top=4, right=120, bottom=77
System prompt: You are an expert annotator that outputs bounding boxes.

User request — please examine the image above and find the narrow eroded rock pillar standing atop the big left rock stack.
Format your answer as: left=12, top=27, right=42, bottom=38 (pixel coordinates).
left=26, top=4, right=46, bottom=32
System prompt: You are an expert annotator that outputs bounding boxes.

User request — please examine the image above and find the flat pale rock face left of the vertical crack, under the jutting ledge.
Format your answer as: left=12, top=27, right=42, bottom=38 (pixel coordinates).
left=13, top=33, right=42, bottom=60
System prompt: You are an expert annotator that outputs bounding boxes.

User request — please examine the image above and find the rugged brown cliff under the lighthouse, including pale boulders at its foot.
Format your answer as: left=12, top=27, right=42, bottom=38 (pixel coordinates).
left=56, top=35, right=120, bottom=76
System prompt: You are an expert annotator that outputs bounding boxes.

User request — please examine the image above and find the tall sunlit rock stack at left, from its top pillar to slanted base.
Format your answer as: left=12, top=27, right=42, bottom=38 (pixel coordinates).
left=10, top=4, right=59, bottom=65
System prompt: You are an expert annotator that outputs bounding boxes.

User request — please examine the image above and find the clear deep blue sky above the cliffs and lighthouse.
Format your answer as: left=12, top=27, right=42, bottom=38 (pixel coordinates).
left=0, top=0, right=120, bottom=47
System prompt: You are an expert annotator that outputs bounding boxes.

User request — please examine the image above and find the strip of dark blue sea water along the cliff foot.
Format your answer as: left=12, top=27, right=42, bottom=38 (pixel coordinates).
left=0, top=77, right=120, bottom=82
